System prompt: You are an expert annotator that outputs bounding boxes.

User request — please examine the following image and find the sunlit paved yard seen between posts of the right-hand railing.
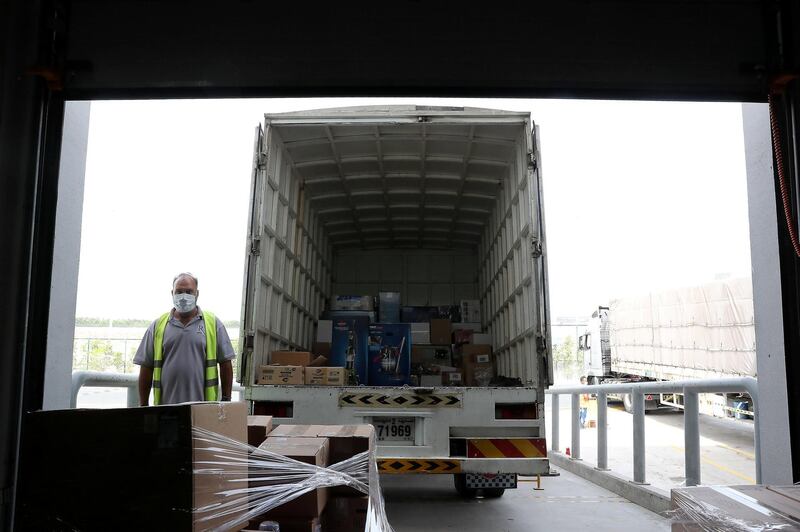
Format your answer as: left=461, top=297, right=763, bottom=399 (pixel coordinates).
left=546, top=396, right=756, bottom=491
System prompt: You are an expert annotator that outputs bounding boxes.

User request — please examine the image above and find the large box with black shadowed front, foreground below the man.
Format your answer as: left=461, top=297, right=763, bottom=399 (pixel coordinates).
left=16, top=401, right=247, bottom=532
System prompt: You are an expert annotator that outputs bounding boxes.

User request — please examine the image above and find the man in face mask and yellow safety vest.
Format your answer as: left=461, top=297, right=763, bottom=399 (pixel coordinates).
left=133, top=273, right=236, bottom=406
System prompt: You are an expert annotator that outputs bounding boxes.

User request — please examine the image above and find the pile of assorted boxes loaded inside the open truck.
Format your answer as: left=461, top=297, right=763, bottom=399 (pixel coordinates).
left=256, top=292, right=504, bottom=386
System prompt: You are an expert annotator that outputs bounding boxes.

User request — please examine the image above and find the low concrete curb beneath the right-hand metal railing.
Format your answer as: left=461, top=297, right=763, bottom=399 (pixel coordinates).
left=547, top=450, right=670, bottom=515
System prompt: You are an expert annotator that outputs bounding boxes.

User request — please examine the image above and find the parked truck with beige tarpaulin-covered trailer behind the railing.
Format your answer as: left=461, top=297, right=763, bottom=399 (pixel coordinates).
left=578, top=277, right=756, bottom=411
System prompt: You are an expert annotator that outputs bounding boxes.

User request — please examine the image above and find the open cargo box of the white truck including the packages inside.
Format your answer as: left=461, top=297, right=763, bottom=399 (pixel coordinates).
left=240, top=106, right=544, bottom=386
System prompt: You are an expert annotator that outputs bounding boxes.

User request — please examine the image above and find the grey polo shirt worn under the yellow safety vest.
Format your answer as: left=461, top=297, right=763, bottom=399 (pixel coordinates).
left=133, top=307, right=236, bottom=404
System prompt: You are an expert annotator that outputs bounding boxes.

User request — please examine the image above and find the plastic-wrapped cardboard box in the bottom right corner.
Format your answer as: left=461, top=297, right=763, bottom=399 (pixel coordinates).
left=672, top=485, right=800, bottom=532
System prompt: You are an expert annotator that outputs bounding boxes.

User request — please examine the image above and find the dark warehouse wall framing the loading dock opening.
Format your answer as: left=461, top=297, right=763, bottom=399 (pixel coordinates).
left=0, top=0, right=800, bottom=528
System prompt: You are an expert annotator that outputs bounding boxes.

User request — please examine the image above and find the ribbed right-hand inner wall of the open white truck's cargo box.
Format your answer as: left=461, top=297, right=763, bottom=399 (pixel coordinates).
left=478, top=124, right=539, bottom=383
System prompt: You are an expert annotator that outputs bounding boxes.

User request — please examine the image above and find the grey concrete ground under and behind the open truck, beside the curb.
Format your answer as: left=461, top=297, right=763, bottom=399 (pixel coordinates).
left=381, top=469, right=670, bottom=532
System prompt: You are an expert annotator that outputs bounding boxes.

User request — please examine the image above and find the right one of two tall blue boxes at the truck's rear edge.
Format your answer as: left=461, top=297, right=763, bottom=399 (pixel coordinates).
left=369, top=323, right=411, bottom=386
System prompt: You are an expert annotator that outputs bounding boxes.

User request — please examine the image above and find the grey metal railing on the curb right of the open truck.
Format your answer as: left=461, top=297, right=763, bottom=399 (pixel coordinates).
left=545, top=377, right=761, bottom=486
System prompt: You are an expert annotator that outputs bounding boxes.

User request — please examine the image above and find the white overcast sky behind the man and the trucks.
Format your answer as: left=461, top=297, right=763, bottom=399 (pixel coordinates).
left=72, top=98, right=750, bottom=320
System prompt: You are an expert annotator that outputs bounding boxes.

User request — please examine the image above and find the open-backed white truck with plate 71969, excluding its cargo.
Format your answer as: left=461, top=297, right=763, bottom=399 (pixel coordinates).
left=239, top=106, right=552, bottom=496
